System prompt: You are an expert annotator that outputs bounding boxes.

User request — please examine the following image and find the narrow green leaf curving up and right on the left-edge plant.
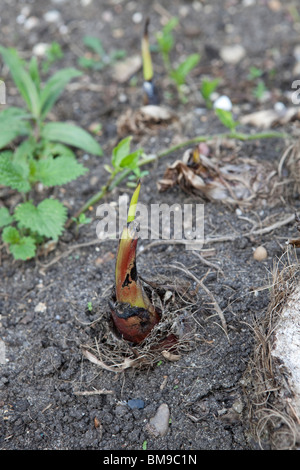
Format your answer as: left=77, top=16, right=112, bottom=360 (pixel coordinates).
left=40, top=67, right=82, bottom=119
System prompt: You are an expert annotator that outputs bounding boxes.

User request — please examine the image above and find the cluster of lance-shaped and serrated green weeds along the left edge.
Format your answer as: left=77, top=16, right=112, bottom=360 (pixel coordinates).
left=0, top=46, right=102, bottom=260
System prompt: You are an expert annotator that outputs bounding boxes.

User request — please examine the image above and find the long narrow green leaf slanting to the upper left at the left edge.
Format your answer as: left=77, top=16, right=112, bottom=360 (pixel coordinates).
left=0, top=46, right=40, bottom=117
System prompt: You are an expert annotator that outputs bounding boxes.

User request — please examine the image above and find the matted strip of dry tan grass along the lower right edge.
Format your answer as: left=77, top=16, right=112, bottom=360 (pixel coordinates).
left=245, top=250, right=300, bottom=450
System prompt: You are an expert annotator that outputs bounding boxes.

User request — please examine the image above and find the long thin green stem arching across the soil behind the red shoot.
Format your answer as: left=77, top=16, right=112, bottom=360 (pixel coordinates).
left=66, top=127, right=289, bottom=227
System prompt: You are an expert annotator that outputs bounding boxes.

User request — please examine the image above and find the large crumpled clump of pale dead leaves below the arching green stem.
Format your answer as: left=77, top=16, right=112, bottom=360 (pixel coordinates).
left=158, top=142, right=278, bottom=206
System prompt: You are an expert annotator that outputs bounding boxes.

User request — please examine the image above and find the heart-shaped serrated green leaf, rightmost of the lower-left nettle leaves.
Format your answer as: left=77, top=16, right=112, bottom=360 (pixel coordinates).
left=14, top=199, right=67, bottom=240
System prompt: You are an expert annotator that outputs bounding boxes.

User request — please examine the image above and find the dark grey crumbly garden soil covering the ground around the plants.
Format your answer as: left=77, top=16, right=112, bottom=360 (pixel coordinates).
left=0, top=0, right=300, bottom=451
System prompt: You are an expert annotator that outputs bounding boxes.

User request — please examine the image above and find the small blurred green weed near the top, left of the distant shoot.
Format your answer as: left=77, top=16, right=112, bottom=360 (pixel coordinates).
left=78, top=36, right=126, bottom=70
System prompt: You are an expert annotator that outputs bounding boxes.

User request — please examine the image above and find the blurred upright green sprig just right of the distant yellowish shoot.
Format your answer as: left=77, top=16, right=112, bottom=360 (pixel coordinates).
left=156, top=17, right=200, bottom=102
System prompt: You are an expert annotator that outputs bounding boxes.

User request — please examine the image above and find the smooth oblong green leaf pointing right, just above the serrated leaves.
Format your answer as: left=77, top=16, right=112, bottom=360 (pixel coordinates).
left=42, top=122, right=102, bottom=156
